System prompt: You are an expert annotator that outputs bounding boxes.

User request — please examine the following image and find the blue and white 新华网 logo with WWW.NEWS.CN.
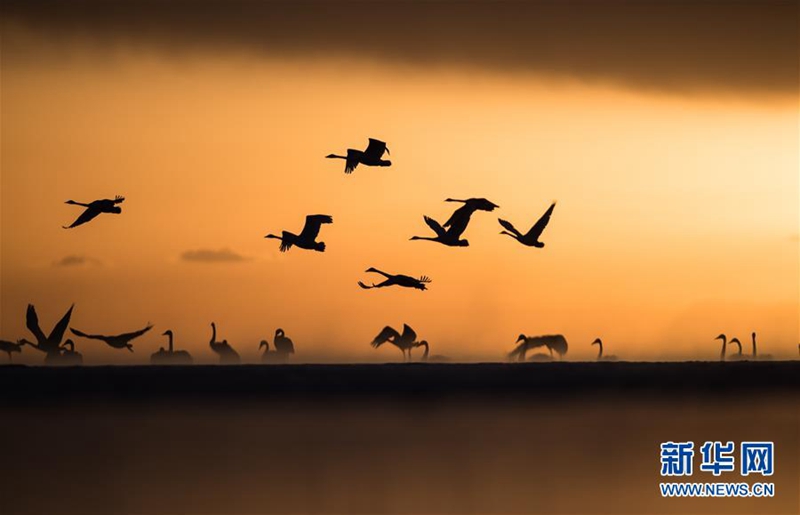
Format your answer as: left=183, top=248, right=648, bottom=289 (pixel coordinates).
left=659, top=441, right=775, bottom=497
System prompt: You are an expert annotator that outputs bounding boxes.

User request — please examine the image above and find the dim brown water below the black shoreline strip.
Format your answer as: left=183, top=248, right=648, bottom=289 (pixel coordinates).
left=0, top=395, right=800, bottom=514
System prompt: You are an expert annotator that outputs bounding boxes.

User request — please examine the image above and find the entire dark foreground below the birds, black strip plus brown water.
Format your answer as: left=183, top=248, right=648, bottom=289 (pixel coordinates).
left=0, top=363, right=800, bottom=514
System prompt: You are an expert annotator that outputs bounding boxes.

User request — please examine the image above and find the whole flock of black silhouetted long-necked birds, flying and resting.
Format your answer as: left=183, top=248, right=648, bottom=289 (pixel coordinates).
left=0, top=138, right=800, bottom=365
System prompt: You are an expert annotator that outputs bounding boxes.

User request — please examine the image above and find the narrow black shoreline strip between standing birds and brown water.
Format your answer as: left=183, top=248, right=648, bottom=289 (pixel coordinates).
left=0, top=361, right=800, bottom=404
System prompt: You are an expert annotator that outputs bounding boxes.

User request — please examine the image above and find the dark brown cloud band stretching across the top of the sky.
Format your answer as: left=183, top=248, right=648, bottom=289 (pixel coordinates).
left=3, top=0, right=798, bottom=96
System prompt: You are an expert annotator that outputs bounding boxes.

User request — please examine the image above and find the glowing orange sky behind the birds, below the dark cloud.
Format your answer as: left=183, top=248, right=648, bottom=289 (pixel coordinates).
left=0, top=22, right=800, bottom=363
